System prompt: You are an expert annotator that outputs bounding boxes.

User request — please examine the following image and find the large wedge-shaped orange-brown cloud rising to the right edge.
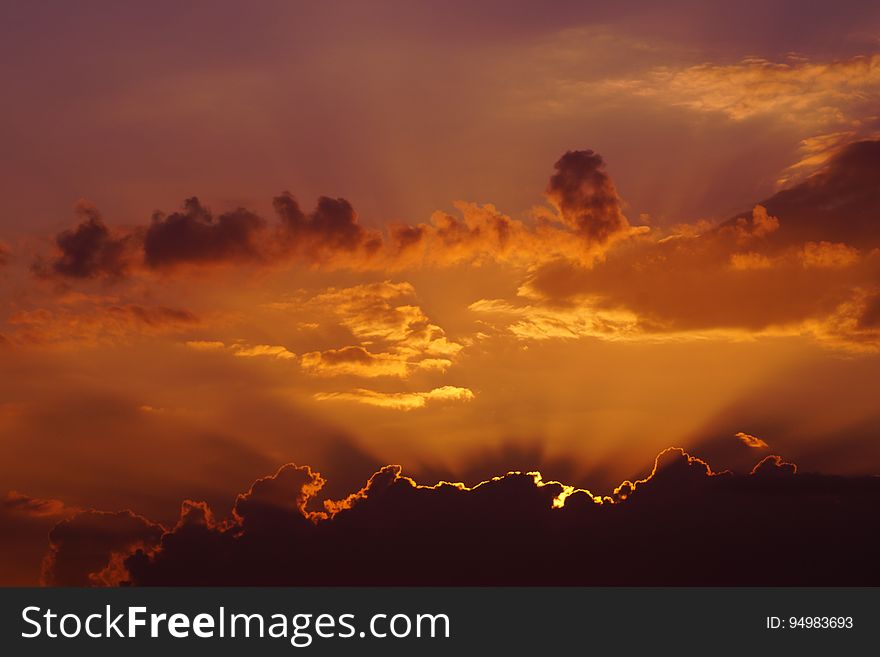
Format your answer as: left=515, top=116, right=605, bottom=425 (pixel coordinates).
left=496, top=141, right=880, bottom=350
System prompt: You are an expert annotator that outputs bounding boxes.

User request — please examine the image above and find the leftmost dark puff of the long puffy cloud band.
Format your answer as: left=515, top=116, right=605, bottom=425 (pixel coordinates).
left=33, top=200, right=132, bottom=279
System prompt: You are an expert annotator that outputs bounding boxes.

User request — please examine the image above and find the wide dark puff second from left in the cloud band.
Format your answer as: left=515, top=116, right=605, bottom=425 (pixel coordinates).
left=143, top=197, right=266, bottom=269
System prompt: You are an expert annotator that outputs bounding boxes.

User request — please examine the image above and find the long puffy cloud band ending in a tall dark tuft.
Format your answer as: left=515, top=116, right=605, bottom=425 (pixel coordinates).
left=25, top=150, right=646, bottom=279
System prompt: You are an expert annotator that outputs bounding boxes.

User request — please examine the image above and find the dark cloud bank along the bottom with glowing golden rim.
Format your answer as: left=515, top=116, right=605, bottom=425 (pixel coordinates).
left=44, top=449, right=880, bottom=586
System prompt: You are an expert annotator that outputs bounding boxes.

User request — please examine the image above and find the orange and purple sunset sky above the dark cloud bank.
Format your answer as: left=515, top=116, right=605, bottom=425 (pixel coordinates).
left=0, top=1, right=880, bottom=584
